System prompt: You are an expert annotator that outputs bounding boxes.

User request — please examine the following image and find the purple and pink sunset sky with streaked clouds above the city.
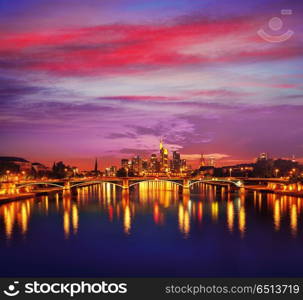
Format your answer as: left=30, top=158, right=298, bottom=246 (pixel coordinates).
left=0, top=0, right=303, bottom=169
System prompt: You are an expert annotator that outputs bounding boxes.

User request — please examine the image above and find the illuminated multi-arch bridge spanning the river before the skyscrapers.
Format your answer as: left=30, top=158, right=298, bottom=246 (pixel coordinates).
left=10, top=177, right=244, bottom=190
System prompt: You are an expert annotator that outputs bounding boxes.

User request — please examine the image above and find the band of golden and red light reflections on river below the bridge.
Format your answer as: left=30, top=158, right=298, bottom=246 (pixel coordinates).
left=0, top=182, right=302, bottom=240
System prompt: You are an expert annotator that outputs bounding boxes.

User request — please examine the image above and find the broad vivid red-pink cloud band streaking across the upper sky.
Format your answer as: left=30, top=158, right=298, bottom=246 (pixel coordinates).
left=0, top=14, right=302, bottom=76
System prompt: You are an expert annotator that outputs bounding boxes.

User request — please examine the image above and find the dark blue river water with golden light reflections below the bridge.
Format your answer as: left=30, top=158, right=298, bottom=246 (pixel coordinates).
left=0, top=183, right=303, bottom=277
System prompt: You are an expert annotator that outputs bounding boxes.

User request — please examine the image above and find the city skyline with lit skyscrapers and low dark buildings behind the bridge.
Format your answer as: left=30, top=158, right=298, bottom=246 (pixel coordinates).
left=0, top=138, right=301, bottom=176
